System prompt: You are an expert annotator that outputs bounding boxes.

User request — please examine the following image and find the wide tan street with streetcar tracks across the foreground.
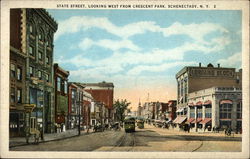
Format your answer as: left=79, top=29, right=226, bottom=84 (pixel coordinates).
left=10, top=124, right=241, bottom=152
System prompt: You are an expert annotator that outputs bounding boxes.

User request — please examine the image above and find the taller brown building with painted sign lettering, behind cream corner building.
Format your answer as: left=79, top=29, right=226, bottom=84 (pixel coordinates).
left=176, top=63, right=242, bottom=117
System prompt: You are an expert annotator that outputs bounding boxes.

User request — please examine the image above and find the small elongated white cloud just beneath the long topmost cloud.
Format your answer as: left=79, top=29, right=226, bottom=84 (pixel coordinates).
left=78, top=38, right=140, bottom=51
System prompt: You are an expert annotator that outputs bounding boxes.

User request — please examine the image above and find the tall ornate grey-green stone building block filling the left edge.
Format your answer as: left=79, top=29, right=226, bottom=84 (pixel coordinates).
left=10, top=9, right=57, bottom=134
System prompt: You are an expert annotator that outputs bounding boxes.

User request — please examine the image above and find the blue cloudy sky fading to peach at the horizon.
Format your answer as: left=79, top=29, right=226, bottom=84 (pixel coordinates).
left=48, top=9, right=242, bottom=110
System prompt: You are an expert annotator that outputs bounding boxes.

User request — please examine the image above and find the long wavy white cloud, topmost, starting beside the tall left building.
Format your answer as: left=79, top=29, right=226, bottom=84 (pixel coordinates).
left=55, top=16, right=160, bottom=39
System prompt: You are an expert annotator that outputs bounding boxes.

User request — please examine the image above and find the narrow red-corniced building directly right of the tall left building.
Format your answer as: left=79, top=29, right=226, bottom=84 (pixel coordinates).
left=54, top=63, right=69, bottom=131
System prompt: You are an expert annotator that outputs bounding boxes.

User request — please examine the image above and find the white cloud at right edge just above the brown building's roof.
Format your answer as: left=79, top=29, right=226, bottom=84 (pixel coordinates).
left=217, top=52, right=242, bottom=68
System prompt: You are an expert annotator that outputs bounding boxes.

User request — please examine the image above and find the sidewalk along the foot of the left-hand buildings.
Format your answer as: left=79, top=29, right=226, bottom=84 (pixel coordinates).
left=9, top=129, right=93, bottom=147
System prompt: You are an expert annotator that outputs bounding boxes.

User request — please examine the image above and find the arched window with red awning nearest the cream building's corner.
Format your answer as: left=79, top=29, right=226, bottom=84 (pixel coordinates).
left=220, top=100, right=233, bottom=119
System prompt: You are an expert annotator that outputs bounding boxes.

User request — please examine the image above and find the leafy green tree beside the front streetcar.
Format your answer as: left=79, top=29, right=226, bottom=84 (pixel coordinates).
left=113, top=99, right=131, bottom=121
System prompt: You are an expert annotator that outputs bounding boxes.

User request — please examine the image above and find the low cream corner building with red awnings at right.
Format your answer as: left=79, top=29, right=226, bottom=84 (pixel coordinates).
left=188, top=87, right=242, bottom=131
